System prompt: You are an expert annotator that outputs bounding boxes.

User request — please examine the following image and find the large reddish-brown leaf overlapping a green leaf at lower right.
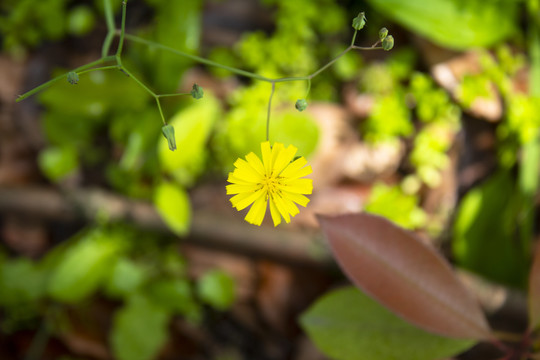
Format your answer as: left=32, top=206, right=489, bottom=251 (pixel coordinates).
left=319, top=213, right=491, bottom=340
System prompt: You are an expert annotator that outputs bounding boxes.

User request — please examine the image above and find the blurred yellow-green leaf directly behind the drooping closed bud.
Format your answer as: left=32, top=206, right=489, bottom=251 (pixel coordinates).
left=158, top=94, right=221, bottom=186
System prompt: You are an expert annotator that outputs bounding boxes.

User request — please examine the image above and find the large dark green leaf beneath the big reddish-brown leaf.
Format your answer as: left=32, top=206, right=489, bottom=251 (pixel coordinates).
left=300, top=287, right=475, bottom=360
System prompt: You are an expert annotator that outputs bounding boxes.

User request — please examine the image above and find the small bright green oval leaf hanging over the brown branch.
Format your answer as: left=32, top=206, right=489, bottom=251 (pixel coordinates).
left=154, top=183, right=191, bottom=236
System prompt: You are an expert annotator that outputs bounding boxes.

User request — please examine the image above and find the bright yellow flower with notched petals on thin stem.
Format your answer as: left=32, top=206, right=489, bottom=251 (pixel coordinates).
left=227, top=141, right=313, bottom=226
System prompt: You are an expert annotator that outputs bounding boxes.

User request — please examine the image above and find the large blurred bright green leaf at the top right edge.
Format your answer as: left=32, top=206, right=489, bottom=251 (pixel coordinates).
left=368, top=0, right=518, bottom=49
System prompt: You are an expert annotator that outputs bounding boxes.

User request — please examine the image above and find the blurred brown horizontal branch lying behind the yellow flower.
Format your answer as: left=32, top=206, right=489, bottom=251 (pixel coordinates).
left=0, top=187, right=333, bottom=266
